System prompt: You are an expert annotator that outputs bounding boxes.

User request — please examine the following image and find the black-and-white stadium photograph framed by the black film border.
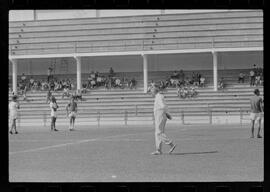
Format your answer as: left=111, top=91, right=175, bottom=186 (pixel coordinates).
left=7, top=9, right=264, bottom=183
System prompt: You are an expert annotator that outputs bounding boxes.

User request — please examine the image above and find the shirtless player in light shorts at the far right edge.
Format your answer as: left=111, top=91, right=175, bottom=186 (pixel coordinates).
left=250, top=89, right=263, bottom=138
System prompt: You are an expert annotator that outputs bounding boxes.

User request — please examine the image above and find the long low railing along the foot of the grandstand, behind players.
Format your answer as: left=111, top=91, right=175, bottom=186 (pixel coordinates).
left=13, top=105, right=258, bottom=127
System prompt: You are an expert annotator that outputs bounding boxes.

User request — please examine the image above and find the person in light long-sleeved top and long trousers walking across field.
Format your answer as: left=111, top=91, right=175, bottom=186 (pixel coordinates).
left=151, top=87, right=176, bottom=155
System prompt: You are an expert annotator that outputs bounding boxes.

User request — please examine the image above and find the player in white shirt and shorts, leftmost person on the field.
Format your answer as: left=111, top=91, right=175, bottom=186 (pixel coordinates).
left=8, top=95, right=20, bottom=134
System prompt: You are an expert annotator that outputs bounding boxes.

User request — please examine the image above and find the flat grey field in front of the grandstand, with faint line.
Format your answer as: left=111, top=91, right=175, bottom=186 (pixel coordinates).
left=9, top=125, right=264, bottom=182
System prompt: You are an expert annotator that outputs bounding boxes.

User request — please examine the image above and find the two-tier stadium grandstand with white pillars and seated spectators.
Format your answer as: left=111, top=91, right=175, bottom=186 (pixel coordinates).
left=9, top=10, right=263, bottom=126
